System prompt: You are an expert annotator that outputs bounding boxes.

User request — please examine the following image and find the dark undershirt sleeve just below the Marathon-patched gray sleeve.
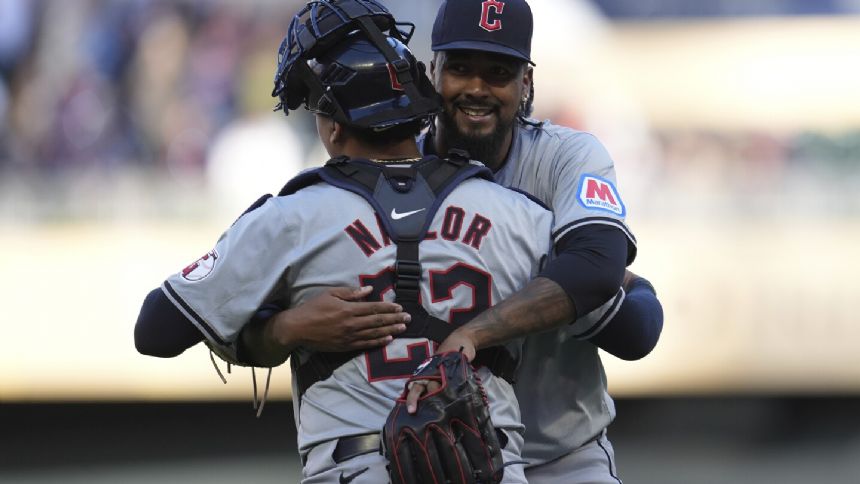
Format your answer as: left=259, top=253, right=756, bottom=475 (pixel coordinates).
left=540, top=224, right=628, bottom=316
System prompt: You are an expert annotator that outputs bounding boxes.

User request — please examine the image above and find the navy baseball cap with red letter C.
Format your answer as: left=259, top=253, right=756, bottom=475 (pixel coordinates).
left=430, top=0, right=534, bottom=65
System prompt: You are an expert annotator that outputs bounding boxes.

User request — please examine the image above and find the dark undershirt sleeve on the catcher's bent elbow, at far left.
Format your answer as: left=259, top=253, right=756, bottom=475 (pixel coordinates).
left=134, top=287, right=203, bottom=358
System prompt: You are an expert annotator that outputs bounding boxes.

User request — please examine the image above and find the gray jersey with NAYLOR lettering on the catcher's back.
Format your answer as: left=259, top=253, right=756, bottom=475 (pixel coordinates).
left=163, top=166, right=552, bottom=480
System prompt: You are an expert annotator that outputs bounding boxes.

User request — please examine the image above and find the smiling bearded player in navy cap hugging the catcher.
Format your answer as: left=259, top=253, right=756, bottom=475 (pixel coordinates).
left=410, top=0, right=662, bottom=483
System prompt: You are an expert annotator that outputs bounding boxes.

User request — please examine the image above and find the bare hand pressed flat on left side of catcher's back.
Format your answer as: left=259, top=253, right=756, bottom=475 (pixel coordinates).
left=273, top=286, right=411, bottom=351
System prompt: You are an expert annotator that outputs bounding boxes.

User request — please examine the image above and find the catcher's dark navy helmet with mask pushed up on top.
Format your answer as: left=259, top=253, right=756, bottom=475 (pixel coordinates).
left=272, top=0, right=440, bottom=130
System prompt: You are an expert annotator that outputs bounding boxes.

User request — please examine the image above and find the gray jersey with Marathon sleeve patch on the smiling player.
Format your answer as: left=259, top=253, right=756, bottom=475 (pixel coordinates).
left=419, top=120, right=635, bottom=465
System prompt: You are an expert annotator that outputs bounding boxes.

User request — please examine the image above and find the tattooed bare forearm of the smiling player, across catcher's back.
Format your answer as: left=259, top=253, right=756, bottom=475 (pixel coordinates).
left=461, top=277, right=576, bottom=349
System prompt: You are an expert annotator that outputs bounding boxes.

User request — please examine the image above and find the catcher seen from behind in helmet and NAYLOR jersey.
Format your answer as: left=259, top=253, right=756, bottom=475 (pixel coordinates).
left=135, top=0, right=552, bottom=483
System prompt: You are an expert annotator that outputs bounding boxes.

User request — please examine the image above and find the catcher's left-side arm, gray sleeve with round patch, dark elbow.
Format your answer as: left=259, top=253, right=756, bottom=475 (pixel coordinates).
left=134, top=199, right=314, bottom=361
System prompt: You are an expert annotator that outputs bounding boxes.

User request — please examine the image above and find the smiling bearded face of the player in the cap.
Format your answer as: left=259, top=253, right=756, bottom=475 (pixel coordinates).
left=431, top=50, right=532, bottom=169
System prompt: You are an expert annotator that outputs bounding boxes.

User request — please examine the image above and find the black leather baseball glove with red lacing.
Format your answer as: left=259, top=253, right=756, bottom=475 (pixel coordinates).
left=382, top=352, right=504, bottom=484
